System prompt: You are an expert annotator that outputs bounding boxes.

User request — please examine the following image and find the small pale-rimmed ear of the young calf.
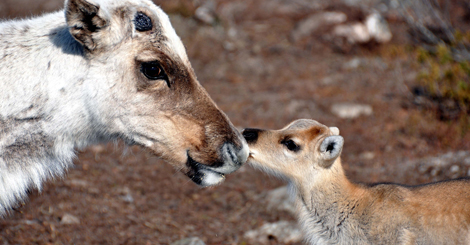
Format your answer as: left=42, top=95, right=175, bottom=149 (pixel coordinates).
left=320, top=135, right=344, bottom=168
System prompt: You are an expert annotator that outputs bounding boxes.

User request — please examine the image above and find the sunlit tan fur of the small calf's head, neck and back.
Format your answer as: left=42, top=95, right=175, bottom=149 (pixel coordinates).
left=247, top=119, right=470, bottom=245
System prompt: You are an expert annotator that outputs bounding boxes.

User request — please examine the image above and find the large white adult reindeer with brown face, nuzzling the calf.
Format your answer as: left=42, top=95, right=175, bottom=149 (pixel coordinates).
left=0, top=0, right=248, bottom=214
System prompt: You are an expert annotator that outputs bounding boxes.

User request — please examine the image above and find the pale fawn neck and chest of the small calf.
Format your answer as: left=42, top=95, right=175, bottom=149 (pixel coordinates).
left=295, top=158, right=366, bottom=243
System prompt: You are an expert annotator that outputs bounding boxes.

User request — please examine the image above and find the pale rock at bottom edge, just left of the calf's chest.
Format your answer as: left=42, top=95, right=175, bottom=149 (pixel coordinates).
left=243, top=221, right=303, bottom=244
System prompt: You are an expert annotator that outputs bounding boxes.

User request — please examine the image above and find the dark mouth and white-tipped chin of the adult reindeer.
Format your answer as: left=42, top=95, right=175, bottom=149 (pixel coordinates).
left=186, top=153, right=225, bottom=186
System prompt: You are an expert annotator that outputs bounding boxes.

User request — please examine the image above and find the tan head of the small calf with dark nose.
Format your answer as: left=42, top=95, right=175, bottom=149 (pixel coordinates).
left=242, top=119, right=344, bottom=179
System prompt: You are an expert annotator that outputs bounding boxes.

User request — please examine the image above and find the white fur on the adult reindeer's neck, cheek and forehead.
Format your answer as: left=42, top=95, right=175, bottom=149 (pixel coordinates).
left=0, top=0, right=248, bottom=215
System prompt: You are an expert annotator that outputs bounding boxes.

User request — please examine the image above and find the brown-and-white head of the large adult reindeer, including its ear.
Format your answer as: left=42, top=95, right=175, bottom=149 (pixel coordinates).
left=66, top=0, right=248, bottom=186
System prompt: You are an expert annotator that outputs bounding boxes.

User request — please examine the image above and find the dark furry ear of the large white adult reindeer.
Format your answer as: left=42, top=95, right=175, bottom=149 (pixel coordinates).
left=65, top=0, right=107, bottom=51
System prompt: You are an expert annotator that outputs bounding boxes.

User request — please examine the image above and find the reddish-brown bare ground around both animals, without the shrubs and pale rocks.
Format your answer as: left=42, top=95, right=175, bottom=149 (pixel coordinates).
left=0, top=0, right=470, bottom=244
